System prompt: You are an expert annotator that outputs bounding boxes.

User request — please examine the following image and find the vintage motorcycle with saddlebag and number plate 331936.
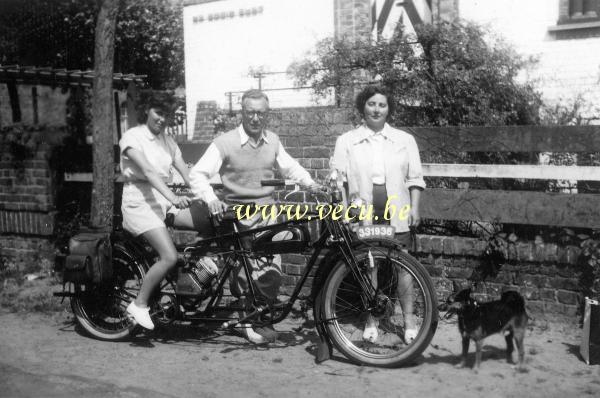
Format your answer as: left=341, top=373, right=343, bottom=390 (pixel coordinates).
left=55, top=180, right=438, bottom=367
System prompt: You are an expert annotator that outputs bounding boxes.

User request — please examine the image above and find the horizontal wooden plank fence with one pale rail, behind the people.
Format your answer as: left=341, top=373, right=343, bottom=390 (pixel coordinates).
left=66, top=126, right=600, bottom=228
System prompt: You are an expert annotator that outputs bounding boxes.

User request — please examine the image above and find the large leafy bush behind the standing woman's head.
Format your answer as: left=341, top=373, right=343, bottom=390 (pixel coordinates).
left=289, top=23, right=541, bottom=126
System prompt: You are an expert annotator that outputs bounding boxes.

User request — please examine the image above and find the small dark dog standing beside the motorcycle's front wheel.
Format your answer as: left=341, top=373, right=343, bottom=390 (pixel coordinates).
left=445, top=289, right=529, bottom=369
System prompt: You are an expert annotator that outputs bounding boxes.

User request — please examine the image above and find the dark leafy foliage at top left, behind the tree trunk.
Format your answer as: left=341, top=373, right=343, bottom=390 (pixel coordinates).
left=0, top=0, right=184, bottom=89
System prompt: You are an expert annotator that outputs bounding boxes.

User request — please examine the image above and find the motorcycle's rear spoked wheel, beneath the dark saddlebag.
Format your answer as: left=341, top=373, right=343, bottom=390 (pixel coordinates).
left=71, top=244, right=145, bottom=340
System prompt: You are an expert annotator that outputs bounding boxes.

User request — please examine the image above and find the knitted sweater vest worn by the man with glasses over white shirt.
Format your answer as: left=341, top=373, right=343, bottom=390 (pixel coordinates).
left=213, top=129, right=279, bottom=204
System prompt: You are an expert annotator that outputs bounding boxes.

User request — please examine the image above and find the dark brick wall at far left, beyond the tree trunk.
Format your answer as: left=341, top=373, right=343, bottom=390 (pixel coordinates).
left=0, top=125, right=65, bottom=270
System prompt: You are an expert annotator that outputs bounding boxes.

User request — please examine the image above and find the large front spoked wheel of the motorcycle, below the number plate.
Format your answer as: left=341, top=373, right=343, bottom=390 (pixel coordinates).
left=322, top=246, right=438, bottom=367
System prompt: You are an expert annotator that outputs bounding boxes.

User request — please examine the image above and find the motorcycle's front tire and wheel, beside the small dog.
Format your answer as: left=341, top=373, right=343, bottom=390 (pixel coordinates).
left=320, top=242, right=438, bottom=368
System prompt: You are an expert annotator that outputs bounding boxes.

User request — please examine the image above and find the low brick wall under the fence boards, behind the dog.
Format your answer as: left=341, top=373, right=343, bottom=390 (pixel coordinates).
left=416, top=235, right=582, bottom=318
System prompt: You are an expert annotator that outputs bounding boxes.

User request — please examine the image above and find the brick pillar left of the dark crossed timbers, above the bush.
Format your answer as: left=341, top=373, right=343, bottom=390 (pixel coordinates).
left=334, top=0, right=372, bottom=41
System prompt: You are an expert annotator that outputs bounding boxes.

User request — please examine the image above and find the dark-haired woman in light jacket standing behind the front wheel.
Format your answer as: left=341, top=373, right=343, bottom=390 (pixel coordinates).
left=331, top=86, right=425, bottom=343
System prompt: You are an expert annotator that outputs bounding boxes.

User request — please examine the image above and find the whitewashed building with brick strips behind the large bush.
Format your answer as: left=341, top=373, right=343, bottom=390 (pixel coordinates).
left=184, top=0, right=600, bottom=138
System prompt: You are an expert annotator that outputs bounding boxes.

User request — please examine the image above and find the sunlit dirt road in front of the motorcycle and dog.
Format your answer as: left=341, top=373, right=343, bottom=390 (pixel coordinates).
left=0, top=313, right=600, bottom=398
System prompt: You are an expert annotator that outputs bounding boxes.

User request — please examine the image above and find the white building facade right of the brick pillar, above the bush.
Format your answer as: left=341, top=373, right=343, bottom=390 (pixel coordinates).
left=373, top=0, right=600, bottom=119
